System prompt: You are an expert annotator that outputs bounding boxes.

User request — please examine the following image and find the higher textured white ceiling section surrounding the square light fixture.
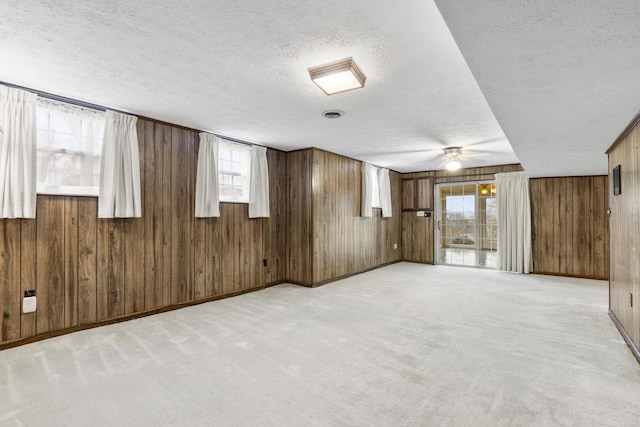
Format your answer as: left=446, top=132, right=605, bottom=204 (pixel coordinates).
left=0, top=0, right=518, bottom=171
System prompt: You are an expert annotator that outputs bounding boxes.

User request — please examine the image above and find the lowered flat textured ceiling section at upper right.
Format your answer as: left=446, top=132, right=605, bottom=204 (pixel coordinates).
left=436, top=0, right=640, bottom=177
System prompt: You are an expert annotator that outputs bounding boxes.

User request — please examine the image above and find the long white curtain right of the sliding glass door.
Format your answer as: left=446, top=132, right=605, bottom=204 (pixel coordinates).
left=496, top=172, right=533, bottom=273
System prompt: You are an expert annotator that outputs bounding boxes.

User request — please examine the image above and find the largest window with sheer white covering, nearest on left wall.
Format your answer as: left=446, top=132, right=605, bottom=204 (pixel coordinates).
left=36, top=98, right=105, bottom=197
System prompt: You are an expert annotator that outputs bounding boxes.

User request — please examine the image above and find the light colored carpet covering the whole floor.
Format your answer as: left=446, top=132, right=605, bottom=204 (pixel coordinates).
left=0, top=263, right=640, bottom=427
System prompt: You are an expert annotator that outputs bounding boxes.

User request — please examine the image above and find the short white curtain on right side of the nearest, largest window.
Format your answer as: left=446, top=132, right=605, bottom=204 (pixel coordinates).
left=98, top=111, right=142, bottom=218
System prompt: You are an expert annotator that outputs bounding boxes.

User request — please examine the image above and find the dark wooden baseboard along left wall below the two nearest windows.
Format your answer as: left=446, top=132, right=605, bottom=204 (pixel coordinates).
left=0, top=281, right=285, bottom=351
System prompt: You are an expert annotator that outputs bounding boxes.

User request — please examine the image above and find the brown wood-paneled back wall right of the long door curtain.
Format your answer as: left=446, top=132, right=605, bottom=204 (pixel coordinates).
left=530, top=176, right=609, bottom=280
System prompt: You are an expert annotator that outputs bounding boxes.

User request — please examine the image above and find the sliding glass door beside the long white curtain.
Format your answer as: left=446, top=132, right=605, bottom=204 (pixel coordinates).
left=435, top=181, right=498, bottom=268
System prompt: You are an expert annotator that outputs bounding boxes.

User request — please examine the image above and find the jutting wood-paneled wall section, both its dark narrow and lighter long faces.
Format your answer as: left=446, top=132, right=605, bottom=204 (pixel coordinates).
left=287, top=149, right=402, bottom=286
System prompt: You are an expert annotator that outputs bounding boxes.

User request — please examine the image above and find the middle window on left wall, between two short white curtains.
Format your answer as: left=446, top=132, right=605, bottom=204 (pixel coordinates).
left=218, top=141, right=251, bottom=203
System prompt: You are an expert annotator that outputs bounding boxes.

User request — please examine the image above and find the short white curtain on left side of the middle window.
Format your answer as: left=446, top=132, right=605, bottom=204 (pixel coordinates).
left=196, top=132, right=220, bottom=218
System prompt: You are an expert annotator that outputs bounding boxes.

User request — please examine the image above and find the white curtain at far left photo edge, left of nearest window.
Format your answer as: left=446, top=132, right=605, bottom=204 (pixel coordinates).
left=0, top=85, right=36, bottom=218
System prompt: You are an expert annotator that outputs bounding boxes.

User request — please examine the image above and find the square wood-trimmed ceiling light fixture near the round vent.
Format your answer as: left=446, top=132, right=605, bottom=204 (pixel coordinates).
left=308, top=57, right=367, bottom=95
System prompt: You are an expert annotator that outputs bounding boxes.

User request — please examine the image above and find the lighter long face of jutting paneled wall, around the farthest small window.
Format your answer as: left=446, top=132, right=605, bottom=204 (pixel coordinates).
left=308, top=149, right=402, bottom=284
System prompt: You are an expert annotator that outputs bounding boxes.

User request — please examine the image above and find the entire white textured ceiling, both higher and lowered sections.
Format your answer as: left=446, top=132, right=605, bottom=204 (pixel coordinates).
left=0, top=0, right=640, bottom=177
